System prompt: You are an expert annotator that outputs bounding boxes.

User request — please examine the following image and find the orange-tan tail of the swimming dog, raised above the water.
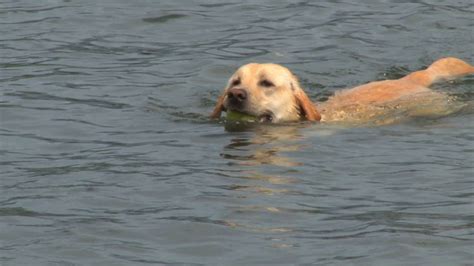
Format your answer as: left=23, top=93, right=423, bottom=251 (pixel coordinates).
left=403, top=57, right=474, bottom=87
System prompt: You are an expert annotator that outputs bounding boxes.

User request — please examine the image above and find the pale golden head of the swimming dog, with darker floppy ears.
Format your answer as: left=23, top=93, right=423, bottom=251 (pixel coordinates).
left=211, top=63, right=321, bottom=123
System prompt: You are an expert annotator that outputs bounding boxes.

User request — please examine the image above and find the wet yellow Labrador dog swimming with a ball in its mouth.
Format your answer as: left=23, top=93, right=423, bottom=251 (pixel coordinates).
left=211, top=57, right=474, bottom=123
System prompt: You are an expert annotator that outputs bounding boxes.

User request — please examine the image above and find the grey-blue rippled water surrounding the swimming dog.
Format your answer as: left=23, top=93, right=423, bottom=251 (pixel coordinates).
left=0, top=0, right=474, bottom=266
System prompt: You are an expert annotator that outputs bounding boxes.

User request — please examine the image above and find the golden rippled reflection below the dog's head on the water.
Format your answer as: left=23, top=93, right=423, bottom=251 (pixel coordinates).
left=221, top=122, right=311, bottom=234
